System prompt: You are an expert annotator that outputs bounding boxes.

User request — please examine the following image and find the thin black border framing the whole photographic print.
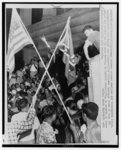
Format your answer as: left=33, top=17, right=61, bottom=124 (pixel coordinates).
left=2, top=2, right=119, bottom=148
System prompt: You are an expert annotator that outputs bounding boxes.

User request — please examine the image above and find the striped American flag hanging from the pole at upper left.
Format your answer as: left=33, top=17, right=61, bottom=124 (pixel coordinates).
left=7, top=8, right=32, bottom=73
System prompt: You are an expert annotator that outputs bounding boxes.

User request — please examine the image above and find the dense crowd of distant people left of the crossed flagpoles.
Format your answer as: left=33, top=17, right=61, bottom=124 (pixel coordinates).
left=7, top=57, right=45, bottom=121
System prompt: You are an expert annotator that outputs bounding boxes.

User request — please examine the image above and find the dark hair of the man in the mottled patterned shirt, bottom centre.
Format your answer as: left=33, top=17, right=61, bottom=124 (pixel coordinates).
left=41, top=105, right=56, bottom=120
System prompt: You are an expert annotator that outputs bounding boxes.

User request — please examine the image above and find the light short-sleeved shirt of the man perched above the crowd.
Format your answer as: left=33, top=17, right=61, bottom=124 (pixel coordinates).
left=87, top=31, right=100, bottom=51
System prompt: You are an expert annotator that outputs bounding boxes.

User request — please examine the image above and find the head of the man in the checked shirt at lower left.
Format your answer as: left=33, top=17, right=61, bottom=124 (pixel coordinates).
left=18, top=98, right=29, bottom=112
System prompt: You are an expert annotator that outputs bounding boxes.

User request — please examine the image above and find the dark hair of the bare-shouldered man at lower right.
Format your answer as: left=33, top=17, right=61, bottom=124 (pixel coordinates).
left=82, top=102, right=99, bottom=120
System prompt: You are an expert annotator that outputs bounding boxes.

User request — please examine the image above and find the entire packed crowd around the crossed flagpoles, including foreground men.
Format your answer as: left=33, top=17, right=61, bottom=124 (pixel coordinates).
left=7, top=25, right=101, bottom=144
